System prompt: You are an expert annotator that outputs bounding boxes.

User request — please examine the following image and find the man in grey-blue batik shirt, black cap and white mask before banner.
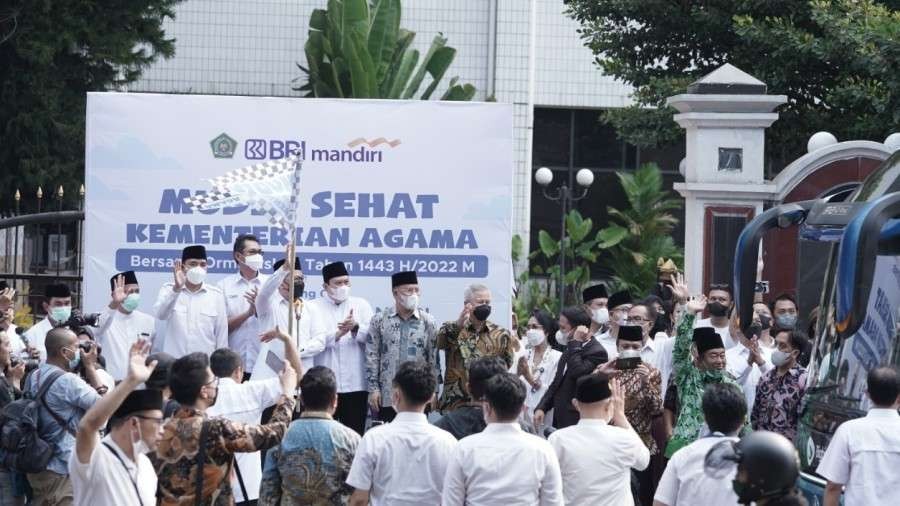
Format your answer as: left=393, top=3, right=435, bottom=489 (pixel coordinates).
left=366, top=271, right=437, bottom=422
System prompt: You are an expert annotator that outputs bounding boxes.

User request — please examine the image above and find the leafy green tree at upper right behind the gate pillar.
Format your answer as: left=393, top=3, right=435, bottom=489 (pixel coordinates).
left=566, top=0, right=900, bottom=165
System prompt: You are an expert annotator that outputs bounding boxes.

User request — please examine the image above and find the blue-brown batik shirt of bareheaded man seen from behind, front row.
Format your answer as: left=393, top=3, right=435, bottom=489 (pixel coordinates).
left=259, top=412, right=360, bottom=506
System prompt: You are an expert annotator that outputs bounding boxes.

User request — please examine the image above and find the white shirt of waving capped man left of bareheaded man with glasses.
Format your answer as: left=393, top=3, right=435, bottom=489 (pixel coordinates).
left=153, top=283, right=228, bottom=358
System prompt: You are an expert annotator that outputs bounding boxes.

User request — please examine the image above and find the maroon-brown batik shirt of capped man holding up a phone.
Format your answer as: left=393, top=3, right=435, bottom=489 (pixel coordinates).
left=618, top=365, right=662, bottom=455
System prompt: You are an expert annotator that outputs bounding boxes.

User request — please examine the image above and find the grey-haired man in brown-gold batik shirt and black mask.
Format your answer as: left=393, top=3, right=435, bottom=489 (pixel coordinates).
left=437, top=284, right=515, bottom=413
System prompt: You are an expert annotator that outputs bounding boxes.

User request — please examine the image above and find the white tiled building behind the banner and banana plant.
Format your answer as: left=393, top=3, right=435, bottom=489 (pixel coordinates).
left=129, top=0, right=668, bottom=260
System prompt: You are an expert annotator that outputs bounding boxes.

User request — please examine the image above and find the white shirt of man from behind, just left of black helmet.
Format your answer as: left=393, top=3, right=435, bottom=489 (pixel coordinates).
left=653, top=436, right=738, bottom=506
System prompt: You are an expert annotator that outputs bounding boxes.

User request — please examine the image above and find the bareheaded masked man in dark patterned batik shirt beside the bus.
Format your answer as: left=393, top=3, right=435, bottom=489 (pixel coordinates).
left=750, top=330, right=809, bottom=441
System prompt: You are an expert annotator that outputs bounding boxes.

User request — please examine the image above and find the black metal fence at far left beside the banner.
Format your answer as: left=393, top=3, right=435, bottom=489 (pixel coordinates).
left=0, top=185, right=84, bottom=316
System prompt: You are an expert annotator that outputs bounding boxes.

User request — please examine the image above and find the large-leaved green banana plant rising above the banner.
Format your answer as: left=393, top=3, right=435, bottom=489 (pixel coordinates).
left=293, top=0, right=475, bottom=101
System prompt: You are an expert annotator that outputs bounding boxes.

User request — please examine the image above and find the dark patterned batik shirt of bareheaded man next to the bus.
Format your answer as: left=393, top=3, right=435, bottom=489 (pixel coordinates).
left=750, top=364, right=806, bottom=441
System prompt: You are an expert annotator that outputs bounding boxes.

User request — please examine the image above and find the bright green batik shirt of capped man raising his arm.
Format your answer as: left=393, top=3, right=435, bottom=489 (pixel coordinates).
left=666, top=313, right=746, bottom=458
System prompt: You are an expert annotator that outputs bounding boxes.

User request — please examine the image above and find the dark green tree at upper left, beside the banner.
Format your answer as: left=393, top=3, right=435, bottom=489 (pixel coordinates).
left=0, top=0, right=181, bottom=209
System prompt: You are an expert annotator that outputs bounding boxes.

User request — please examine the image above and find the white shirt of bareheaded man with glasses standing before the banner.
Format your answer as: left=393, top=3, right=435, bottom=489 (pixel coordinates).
left=216, top=272, right=269, bottom=372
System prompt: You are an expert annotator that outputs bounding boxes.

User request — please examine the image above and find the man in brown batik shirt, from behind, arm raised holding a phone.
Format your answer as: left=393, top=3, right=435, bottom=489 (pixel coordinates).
left=150, top=353, right=297, bottom=506
